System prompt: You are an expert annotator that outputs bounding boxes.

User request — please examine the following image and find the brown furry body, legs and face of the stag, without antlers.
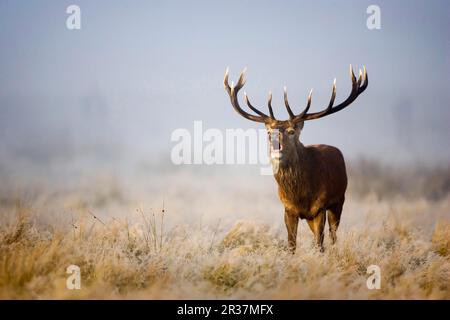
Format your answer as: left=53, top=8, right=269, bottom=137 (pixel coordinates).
left=266, top=122, right=347, bottom=251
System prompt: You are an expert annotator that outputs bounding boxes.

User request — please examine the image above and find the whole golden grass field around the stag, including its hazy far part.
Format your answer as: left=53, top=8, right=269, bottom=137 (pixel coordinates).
left=0, top=163, right=450, bottom=299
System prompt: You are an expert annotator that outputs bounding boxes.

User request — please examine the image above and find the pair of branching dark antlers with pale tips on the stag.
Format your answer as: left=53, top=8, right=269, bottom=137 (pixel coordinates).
left=224, top=65, right=369, bottom=122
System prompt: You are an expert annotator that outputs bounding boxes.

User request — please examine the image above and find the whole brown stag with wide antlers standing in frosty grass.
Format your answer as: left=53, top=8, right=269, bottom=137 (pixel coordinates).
left=224, top=65, right=369, bottom=253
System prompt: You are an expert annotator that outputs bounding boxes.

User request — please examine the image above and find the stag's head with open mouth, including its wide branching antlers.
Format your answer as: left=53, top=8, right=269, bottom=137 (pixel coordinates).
left=224, top=65, right=369, bottom=163
